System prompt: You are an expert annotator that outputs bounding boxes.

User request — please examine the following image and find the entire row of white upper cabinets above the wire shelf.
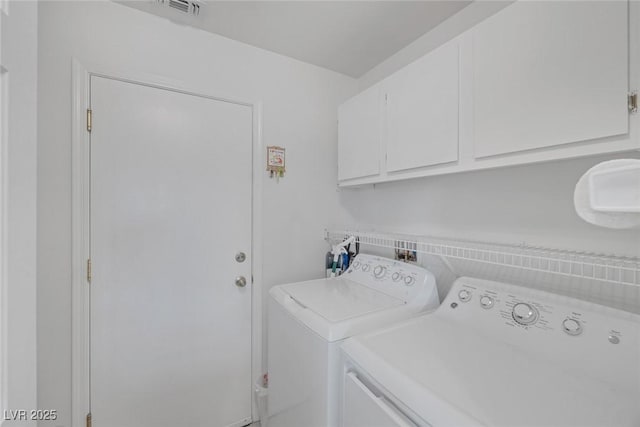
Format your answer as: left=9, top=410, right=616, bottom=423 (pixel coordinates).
left=338, top=0, right=640, bottom=186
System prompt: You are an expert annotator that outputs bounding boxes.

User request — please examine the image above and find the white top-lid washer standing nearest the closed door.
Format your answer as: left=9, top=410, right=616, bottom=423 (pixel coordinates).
left=268, top=254, right=439, bottom=427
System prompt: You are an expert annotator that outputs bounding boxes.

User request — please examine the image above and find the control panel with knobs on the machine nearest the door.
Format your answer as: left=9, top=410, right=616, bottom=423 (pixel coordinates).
left=348, top=254, right=437, bottom=302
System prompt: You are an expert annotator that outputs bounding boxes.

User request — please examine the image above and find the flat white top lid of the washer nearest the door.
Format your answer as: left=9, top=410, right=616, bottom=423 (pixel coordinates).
left=282, top=278, right=404, bottom=323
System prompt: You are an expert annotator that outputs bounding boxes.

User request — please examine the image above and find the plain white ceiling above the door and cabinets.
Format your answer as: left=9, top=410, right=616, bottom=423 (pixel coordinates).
left=119, top=0, right=471, bottom=77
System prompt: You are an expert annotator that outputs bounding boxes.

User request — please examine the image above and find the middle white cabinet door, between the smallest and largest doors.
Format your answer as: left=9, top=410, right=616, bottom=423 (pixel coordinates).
left=387, top=41, right=459, bottom=172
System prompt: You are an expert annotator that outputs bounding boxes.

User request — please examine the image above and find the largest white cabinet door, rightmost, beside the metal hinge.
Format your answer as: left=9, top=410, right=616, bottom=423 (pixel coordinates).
left=472, top=0, right=629, bottom=157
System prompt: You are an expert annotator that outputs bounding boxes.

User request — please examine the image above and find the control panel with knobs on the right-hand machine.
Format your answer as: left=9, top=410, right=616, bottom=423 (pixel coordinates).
left=440, top=277, right=640, bottom=392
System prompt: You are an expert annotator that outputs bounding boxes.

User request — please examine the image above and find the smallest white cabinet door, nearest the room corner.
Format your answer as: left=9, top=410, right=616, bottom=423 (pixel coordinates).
left=338, top=85, right=381, bottom=180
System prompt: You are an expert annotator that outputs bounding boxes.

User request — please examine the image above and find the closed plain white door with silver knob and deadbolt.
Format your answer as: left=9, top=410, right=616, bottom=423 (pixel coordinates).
left=90, top=77, right=252, bottom=427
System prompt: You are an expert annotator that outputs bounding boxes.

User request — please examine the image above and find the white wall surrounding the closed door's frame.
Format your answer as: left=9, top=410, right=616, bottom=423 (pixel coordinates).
left=38, top=1, right=357, bottom=426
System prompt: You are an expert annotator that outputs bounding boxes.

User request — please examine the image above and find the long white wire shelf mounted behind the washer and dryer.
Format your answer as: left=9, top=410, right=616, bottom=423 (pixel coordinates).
left=325, top=229, right=640, bottom=286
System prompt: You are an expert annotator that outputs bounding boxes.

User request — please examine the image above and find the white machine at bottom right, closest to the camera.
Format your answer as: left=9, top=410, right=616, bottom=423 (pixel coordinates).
left=343, top=277, right=640, bottom=427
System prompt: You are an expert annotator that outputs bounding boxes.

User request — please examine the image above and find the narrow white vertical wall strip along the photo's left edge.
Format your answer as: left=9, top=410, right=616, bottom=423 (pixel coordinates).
left=0, top=1, right=38, bottom=426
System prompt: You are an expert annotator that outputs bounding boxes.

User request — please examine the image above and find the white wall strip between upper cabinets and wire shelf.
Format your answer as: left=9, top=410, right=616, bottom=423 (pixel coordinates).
left=340, top=152, right=640, bottom=256
